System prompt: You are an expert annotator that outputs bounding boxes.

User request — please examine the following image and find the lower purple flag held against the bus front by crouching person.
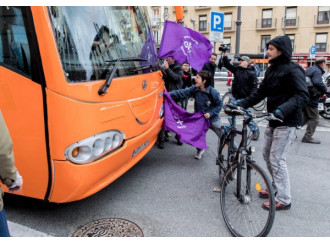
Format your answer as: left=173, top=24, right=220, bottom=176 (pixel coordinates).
left=163, top=90, right=210, bottom=149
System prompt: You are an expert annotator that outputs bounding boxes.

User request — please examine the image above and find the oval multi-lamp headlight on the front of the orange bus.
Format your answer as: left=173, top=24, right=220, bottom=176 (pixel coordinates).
left=64, top=130, right=125, bottom=164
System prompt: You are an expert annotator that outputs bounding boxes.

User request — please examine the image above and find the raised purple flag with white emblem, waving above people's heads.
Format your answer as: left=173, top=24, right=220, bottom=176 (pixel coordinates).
left=158, top=20, right=213, bottom=71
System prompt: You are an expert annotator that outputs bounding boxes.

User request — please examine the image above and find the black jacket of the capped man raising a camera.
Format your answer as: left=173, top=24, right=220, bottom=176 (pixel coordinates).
left=223, top=56, right=258, bottom=99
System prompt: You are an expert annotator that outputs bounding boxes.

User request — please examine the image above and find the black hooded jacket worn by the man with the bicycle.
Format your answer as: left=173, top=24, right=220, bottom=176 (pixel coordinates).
left=240, top=36, right=309, bottom=127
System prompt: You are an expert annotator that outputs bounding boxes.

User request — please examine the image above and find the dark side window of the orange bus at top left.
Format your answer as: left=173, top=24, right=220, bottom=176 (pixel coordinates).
left=0, top=7, right=31, bottom=76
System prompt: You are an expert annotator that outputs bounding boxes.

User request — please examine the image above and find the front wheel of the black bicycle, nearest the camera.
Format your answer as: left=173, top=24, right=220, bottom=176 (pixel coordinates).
left=220, top=162, right=275, bottom=237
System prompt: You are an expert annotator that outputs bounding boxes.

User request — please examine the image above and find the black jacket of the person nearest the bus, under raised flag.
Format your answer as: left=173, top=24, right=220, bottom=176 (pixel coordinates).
left=161, top=62, right=183, bottom=92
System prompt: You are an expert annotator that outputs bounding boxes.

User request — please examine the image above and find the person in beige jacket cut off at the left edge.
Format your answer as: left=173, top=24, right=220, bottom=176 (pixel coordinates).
left=0, top=111, right=23, bottom=237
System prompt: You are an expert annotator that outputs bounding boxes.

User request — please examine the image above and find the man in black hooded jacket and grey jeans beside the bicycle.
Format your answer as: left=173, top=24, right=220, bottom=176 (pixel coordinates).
left=239, top=36, right=308, bottom=210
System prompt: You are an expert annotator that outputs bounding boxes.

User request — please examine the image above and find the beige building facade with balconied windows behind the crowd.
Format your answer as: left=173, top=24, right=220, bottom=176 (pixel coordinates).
left=148, top=6, right=330, bottom=71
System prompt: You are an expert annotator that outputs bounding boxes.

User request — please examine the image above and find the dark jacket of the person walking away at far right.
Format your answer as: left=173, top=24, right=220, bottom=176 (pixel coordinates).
left=305, top=65, right=327, bottom=107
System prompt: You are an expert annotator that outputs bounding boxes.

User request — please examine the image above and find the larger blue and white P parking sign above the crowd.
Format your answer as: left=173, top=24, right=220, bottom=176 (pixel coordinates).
left=210, top=11, right=225, bottom=42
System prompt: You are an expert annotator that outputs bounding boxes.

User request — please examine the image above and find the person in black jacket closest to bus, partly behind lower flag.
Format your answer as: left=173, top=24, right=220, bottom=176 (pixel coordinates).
left=158, top=57, right=183, bottom=149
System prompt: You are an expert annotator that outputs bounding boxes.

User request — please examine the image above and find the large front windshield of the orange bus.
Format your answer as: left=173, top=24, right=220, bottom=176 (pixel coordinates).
left=48, top=6, right=157, bottom=82
